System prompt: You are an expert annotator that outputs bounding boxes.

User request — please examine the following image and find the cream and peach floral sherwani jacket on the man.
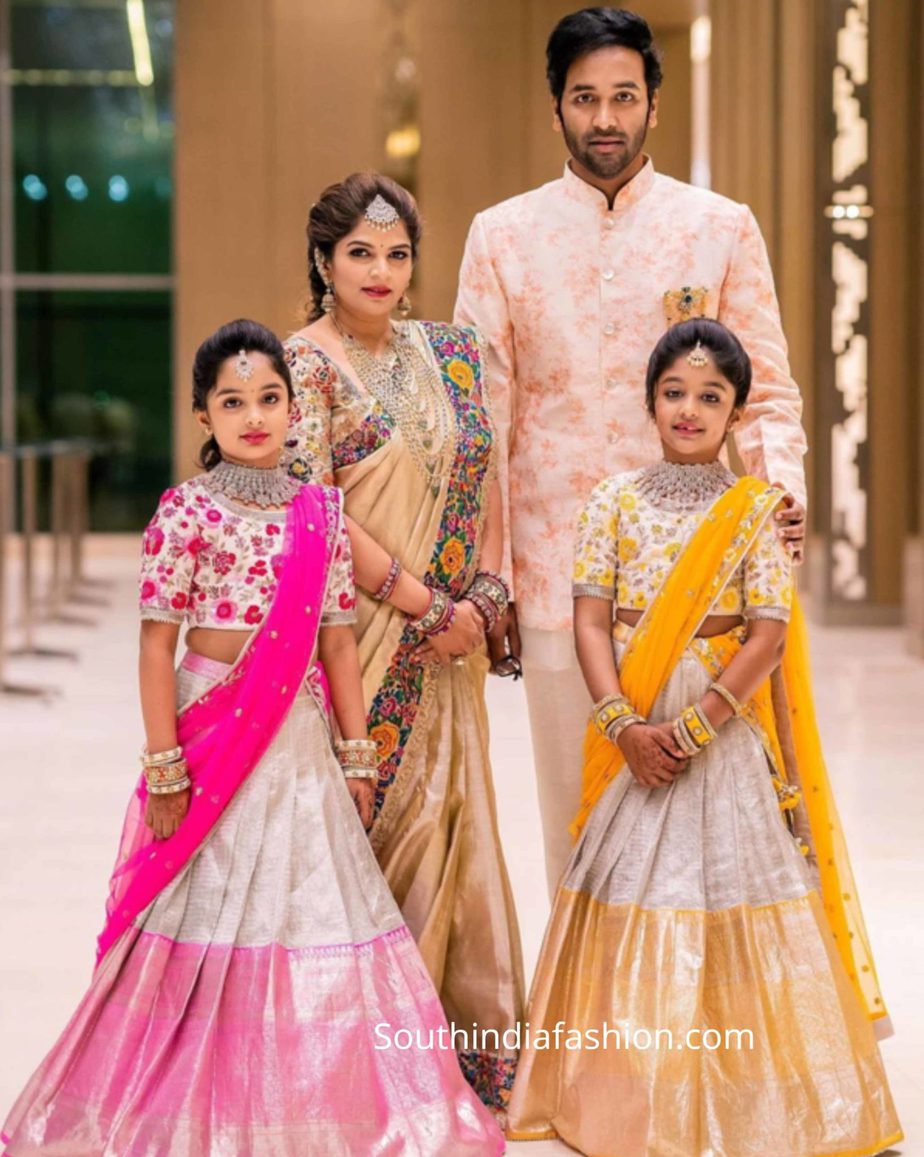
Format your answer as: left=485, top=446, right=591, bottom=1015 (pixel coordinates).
left=456, top=160, right=806, bottom=631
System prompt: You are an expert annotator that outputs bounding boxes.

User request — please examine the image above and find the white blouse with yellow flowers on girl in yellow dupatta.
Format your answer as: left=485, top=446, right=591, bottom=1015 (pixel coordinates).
left=571, top=467, right=792, bottom=621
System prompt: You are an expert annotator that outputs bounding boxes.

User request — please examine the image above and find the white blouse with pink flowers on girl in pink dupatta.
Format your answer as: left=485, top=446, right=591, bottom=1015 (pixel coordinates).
left=140, top=474, right=356, bottom=631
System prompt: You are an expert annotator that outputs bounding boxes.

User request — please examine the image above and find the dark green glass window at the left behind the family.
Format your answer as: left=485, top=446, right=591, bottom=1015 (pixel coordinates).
left=0, top=0, right=175, bottom=530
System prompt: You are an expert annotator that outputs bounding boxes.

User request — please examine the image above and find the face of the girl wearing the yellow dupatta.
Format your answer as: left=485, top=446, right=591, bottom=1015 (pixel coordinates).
left=655, top=349, right=740, bottom=464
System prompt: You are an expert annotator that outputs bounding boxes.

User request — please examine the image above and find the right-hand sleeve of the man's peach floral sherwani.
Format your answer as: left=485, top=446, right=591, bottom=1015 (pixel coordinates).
left=718, top=205, right=807, bottom=504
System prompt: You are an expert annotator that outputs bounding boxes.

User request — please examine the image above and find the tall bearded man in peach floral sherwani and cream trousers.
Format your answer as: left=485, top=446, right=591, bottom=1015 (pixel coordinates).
left=456, top=8, right=806, bottom=890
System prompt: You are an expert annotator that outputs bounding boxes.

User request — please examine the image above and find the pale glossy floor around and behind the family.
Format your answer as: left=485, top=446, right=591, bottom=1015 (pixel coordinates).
left=0, top=537, right=924, bottom=1157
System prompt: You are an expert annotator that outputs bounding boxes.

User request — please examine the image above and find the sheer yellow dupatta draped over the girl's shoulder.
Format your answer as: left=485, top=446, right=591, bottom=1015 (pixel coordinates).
left=569, top=478, right=887, bottom=1020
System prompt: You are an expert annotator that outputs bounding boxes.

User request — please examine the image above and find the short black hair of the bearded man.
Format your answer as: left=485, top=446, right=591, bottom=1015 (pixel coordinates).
left=546, top=8, right=663, bottom=105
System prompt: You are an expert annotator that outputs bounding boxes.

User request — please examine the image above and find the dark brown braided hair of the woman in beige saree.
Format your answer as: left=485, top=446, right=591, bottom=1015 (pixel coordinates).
left=305, top=172, right=421, bottom=322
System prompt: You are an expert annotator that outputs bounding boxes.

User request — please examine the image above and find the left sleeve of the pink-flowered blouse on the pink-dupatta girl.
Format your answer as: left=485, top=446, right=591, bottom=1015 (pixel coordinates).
left=139, top=488, right=201, bottom=624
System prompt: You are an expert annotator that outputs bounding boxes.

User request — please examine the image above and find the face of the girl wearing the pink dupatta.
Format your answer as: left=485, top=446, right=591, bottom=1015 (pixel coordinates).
left=195, top=352, right=290, bottom=466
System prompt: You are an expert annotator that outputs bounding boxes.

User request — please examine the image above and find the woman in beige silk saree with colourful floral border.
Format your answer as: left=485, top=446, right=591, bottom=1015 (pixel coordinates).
left=286, top=174, right=523, bottom=1112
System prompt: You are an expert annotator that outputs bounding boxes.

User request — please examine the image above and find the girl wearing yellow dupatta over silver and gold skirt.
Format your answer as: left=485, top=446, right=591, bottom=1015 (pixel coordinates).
left=509, top=319, right=901, bottom=1157
